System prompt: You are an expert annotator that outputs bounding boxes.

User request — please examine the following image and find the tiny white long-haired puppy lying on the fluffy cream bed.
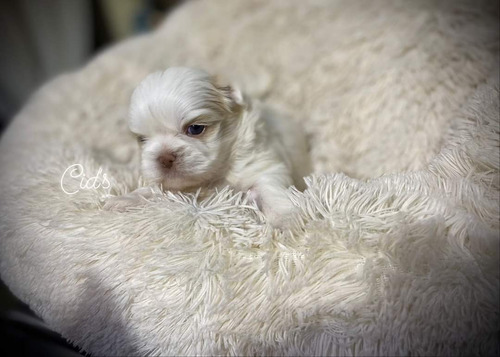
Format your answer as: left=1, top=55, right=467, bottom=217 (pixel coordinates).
left=104, top=67, right=310, bottom=227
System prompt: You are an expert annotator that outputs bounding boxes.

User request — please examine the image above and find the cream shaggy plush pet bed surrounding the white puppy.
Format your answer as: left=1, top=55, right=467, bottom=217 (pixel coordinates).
left=0, top=0, right=500, bottom=356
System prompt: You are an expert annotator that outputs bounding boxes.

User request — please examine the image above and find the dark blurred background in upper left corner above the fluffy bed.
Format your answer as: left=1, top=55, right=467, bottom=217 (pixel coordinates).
left=0, top=0, right=181, bottom=130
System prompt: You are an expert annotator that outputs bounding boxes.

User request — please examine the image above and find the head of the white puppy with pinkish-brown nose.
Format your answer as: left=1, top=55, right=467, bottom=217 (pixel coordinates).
left=129, top=67, right=243, bottom=190
